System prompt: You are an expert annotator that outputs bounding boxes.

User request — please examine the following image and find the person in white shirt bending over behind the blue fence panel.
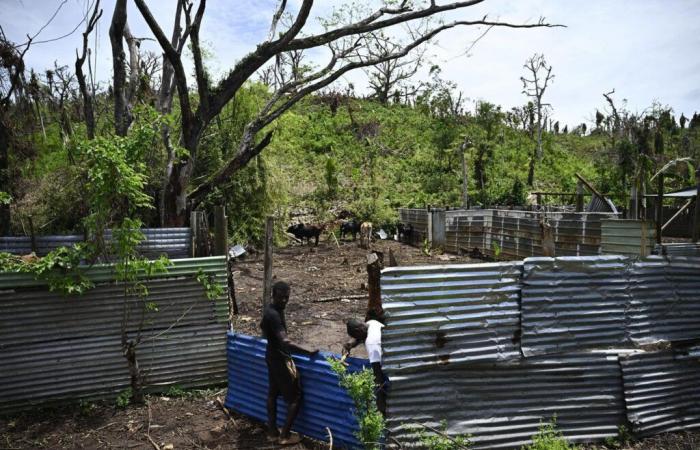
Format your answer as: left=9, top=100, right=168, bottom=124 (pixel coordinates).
left=343, top=319, right=389, bottom=415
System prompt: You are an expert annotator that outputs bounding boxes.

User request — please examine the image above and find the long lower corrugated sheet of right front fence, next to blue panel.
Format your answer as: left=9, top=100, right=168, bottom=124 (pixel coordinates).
left=387, top=353, right=625, bottom=449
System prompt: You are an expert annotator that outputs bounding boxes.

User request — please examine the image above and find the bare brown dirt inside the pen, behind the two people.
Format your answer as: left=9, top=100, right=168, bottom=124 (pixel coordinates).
left=234, top=238, right=478, bottom=357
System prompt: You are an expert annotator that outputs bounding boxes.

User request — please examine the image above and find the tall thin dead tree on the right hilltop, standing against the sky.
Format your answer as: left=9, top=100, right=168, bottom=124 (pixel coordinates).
left=520, top=53, right=554, bottom=186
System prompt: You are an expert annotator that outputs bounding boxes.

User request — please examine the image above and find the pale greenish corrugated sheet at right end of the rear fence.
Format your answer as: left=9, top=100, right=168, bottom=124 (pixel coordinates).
left=601, top=219, right=656, bottom=256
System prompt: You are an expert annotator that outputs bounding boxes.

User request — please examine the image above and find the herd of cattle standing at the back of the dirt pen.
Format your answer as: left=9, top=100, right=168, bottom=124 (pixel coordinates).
left=287, top=219, right=413, bottom=247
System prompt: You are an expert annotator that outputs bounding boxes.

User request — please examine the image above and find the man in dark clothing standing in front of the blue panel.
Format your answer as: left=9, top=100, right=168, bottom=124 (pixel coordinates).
left=260, top=281, right=318, bottom=445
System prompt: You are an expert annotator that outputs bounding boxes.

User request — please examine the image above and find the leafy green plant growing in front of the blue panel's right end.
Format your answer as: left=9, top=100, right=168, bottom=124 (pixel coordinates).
left=327, top=358, right=385, bottom=450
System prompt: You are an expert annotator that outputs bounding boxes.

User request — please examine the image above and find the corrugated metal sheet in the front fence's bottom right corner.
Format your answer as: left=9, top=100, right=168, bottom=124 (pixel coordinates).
left=620, top=351, right=700, bottom=436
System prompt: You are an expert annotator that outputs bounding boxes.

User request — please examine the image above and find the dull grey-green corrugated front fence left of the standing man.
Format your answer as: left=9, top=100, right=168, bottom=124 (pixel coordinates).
left=0, top=257, right=228, bottom=413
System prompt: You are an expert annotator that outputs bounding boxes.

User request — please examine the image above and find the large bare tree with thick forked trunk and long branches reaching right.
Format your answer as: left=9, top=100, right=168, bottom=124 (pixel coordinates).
left=130, top=0, right=554, bottom=226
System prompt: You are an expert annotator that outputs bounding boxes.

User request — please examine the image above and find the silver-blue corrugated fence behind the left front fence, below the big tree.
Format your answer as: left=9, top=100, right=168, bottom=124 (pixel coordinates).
left=0, top=228, right=192, bottom=258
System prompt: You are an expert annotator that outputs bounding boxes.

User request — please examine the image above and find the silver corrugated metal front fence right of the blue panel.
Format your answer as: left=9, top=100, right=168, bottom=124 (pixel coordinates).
left=382, top=256, right=700, bottom=448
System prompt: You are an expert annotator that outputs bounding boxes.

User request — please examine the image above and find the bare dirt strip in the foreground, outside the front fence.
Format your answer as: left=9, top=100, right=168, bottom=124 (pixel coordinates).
left=0, top=388, right=700, bottom=450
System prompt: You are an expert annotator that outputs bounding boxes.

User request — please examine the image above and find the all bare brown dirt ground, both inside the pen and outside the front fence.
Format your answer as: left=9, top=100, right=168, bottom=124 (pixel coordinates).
left=0, top=239, right=700, bottom=450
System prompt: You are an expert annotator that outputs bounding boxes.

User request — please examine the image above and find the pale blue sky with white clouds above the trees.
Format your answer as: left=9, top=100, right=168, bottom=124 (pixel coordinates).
left=0, top=0, right=700, bottom=125
